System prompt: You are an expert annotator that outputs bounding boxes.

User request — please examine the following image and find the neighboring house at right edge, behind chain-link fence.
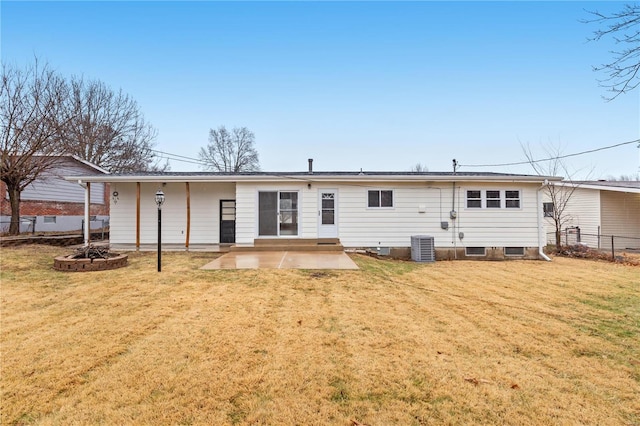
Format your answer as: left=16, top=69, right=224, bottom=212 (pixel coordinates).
left=544, top=180, right=640, bottom=250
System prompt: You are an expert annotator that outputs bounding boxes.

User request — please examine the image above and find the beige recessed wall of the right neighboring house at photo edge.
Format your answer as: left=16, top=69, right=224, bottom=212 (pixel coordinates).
left=600, top=191, right=640, bottom=249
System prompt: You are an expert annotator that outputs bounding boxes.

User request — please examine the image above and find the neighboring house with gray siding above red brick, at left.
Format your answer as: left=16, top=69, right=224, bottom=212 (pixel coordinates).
left=0, top=155, right=109, bottom=232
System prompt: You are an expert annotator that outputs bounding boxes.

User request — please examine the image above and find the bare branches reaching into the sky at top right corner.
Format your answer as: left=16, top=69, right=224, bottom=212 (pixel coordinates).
left=582, top=4, right=640, bottom=101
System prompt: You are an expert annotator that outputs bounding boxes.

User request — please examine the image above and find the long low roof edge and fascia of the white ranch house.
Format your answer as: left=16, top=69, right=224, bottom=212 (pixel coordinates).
left=65, top=171, right=562, bottom=183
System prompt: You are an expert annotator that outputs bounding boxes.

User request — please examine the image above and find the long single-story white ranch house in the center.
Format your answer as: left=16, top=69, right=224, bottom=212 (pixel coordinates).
left=66, top=163, right=560, bottom=259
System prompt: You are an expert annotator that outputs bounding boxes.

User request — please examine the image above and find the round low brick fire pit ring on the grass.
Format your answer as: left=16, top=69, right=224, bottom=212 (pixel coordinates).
left=53, top=245, right=128, bottom=272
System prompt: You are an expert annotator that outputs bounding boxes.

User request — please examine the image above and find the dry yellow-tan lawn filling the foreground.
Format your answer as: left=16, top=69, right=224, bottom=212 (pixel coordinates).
left=0, top=247, right=640, bottom=425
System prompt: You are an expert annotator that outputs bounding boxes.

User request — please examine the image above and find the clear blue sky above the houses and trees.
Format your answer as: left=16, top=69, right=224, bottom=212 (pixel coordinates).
left=0, top=1, right=640, bottom=178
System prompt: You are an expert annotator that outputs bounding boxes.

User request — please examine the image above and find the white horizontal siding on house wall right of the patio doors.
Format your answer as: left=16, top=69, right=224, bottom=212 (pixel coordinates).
left=339, top=184, right=538, bottom=247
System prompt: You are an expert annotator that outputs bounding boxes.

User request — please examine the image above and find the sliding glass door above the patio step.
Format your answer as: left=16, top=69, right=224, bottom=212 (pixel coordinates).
left=258, top=191, right=298, bottom=237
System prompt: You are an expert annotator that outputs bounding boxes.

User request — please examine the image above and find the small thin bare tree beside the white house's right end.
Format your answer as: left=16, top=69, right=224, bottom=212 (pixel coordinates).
left=520, top=144, right=580, bottom=251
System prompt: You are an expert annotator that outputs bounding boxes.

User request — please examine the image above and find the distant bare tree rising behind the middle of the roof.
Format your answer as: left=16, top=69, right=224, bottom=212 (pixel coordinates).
left=199, top=126, right=260, bottom=173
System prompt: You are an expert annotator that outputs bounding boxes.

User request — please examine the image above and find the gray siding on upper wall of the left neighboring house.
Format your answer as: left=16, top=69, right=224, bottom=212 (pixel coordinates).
left=20, top=158, right=105, bottom=204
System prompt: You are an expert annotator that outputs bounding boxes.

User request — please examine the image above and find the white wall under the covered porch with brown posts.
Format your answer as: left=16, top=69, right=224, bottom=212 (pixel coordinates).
left=110, top=183, right=235, bottom=244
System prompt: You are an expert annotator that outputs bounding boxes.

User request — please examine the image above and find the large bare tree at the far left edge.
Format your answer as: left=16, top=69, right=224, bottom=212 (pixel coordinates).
left=0, top=58, right=68, bottom=235
